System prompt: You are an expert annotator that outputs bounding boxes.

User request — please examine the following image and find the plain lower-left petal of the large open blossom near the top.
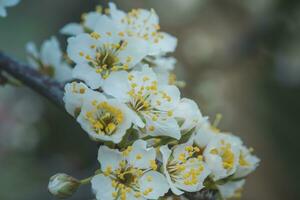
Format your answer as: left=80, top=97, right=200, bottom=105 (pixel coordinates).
left=72, top=64, right=103, bottom=89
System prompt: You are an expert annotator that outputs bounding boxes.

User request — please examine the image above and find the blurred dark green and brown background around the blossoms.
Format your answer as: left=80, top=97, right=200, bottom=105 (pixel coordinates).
left=0, top=0, right=300, bottom=200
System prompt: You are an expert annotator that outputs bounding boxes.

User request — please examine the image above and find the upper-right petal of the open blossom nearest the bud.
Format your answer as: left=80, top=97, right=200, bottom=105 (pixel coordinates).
left=128, top=140, right=156, bottom=169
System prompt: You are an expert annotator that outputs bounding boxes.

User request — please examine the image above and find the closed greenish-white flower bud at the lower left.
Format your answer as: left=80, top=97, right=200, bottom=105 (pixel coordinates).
left=48, top=173, right=80, bottom=199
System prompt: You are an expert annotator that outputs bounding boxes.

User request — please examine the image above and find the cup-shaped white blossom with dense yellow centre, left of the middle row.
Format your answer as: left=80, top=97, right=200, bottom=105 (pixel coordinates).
left=77, top=93, right=142, bottom=143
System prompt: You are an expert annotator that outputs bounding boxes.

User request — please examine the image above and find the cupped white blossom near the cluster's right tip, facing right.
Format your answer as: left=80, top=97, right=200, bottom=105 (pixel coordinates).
left=203, top=133, right=241, bottom=181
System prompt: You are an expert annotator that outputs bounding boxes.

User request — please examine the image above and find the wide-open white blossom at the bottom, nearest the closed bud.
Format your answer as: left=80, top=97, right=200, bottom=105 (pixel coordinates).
left=92, top=140, right=169, bottom=200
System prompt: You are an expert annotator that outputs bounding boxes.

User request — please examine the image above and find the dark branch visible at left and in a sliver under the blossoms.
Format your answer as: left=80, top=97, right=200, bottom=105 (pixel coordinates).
left=0, top=51, right=216, bottom=200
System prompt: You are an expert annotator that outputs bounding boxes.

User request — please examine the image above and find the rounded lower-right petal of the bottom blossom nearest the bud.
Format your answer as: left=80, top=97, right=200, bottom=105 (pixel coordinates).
left=139, top=171, right=170, bottom=199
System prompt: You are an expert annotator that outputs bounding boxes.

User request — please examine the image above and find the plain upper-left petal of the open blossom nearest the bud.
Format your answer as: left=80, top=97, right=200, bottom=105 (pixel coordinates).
left=98, top=146, right=123, bottom=171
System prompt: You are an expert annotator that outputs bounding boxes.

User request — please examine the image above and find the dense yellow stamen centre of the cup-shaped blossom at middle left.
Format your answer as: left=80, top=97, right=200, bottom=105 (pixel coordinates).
left=86, top=102, right=124, bottom=135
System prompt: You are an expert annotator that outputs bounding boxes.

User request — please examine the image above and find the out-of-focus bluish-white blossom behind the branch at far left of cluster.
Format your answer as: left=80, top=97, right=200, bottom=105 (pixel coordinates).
left=26, top=37, right=72, bottom=82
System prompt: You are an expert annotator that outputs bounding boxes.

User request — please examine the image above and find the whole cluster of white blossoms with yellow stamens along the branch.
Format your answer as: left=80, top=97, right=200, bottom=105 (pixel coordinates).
left=45, top=3, right=259, bottom=200
